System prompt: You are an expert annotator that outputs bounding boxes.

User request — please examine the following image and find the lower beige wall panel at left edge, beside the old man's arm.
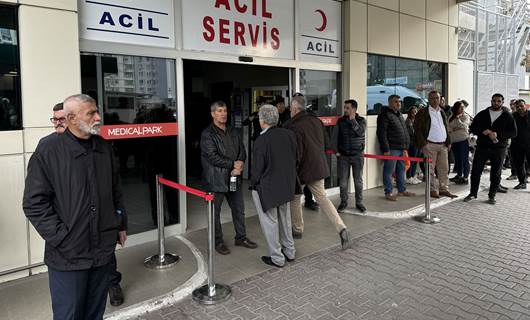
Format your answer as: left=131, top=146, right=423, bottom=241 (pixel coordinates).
left=0, top=154, right=28, bottom=271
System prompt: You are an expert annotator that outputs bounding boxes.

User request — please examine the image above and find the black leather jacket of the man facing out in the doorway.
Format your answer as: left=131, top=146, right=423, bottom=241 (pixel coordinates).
left=201, top=123, right=246, bottom=192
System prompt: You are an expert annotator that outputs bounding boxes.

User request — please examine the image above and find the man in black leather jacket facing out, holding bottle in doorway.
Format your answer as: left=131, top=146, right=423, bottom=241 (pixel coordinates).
left=201, top=101, right=258, bottom=254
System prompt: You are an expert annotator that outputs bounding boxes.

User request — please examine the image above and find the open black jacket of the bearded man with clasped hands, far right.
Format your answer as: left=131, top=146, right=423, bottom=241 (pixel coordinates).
left=469, top=107, right=517, bottom=148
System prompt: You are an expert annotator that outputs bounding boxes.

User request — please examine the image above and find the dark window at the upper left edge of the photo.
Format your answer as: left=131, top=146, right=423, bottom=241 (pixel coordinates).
left=0, top=6, right=22, bottom=131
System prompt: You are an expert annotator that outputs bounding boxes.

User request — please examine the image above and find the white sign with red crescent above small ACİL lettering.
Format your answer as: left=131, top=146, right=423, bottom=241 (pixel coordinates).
left=298, top=0, right=342, bottom=63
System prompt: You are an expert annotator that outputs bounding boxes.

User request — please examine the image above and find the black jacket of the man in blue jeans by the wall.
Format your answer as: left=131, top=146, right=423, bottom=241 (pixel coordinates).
left=377, top=107, right=410, bottom=153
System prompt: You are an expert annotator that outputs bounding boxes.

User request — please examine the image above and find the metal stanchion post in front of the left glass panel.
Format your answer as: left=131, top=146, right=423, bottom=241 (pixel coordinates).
left=144, top=174, right=180, bottom=269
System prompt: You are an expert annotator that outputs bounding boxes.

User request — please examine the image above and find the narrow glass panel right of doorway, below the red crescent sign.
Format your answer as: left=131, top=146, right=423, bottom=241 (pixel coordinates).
left=300, top=70, right=342, bottom=188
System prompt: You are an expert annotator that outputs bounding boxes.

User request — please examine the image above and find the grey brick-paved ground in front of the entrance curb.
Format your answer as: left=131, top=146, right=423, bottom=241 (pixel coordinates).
left=142, top=191, right=530, bottom=320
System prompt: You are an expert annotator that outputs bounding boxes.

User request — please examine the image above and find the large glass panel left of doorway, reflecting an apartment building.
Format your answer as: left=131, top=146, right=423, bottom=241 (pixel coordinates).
left=81, top=54, right=180, bottom=234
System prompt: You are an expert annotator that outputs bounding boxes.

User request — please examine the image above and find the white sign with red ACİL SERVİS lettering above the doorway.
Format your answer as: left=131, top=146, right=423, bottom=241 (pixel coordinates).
left=182, top=0, right=294, bottom=59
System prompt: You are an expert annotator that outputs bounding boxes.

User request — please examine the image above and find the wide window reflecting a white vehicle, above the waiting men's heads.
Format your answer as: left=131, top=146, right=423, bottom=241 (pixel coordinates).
left=366, top=55, right=445, bottom=115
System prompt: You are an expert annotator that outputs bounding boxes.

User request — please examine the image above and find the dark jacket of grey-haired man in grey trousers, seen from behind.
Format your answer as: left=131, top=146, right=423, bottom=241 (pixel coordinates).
left=251, top=127, right=296, bottom=211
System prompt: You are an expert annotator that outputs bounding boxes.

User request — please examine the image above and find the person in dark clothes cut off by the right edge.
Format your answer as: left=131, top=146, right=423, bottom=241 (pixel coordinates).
left=510, top=100, right=530, bottom=190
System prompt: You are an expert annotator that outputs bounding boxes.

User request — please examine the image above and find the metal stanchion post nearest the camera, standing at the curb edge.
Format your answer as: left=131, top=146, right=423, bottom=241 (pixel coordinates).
left=193, top=194, right=232, bottom=304
